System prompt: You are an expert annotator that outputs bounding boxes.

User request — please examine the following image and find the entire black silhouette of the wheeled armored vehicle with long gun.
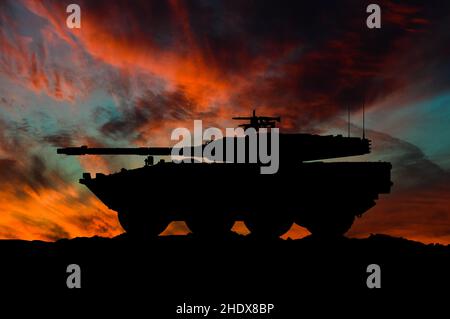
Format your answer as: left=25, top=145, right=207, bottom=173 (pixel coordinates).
left=57, top=112, right=392, bottom=238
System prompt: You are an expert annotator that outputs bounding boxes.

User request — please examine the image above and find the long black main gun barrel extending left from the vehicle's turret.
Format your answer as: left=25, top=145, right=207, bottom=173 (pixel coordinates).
left=56, top=146, right=172, bottom=156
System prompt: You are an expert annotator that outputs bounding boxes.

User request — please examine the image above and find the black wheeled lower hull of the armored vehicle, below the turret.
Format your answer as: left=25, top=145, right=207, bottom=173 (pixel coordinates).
left=80, top=162, right=392, bottom=239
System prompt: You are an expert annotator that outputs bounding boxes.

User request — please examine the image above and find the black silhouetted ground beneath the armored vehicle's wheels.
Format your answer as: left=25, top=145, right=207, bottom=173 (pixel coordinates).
left=0, top=235, right=450, bottom=318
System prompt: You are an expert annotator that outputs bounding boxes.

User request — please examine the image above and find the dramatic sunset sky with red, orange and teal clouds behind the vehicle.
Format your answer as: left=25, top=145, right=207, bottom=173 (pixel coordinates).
left=0, top=0, right=450, bottom=243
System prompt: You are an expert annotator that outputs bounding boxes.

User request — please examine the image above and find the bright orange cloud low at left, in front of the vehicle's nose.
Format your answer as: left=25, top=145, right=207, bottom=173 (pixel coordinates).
left=0, top=186, right=122, bottom=241
